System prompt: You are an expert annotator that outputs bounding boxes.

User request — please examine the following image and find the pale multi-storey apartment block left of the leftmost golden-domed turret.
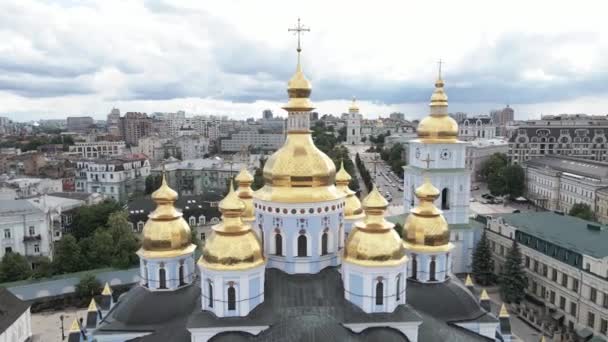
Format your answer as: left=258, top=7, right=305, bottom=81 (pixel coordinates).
left=76, top=155, right=150, bottom=202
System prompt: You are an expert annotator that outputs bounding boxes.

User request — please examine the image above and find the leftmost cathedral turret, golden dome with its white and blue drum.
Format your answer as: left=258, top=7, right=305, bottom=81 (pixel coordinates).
left=137, top=172, right=196, bottom=291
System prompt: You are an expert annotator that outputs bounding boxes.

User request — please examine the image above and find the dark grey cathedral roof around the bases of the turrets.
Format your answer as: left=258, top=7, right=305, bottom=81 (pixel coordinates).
left=96, top=268, right=496, bottom=342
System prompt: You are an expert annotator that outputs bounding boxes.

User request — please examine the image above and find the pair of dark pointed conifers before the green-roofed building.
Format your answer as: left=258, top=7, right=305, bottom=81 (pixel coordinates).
left=472, top=231, right=528, bottom=303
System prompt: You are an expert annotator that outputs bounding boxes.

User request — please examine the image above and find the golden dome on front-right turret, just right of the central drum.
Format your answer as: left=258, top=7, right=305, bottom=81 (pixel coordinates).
left=344, top=187, right=407, bottom=267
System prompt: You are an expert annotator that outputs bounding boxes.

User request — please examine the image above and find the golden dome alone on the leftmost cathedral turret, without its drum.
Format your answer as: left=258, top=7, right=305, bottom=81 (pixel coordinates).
left=138, top=173, right=196, bottom=258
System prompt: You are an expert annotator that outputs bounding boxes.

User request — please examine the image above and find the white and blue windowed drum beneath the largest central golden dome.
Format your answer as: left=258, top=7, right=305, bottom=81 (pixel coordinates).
left=254, top=199, right=344, bottom=274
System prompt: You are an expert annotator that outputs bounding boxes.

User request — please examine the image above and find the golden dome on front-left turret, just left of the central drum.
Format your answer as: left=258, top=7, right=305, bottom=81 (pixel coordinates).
left=198, top=182, right=265, bottom=270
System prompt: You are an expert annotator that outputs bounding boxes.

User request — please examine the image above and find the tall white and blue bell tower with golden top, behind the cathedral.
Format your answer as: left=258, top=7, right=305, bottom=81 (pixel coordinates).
left=403, top=69, right=471, bottom=224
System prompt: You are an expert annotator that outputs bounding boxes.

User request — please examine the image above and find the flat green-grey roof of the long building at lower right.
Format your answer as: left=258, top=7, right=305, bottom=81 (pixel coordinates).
left=500, top=211, right=608, bottom=258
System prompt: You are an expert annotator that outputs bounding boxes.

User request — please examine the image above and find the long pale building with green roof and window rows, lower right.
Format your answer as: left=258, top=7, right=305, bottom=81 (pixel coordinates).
left=486, top=212, right=608, bottom=341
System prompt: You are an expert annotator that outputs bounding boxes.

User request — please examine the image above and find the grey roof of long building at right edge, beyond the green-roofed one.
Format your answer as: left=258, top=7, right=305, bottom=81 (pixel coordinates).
left=525, top=156, right=608, bottom=180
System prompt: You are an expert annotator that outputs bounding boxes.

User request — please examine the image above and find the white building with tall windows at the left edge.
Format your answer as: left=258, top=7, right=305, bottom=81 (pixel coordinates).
left=0, top=200, right=53, bottom=268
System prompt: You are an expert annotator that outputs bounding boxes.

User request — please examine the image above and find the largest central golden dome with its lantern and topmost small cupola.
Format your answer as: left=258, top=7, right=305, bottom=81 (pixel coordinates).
left=254, top=48, right=345, bottom=203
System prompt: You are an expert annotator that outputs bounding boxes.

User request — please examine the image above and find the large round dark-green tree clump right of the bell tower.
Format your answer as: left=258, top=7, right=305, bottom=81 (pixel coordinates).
left=480, top=153, right=525, bottom=199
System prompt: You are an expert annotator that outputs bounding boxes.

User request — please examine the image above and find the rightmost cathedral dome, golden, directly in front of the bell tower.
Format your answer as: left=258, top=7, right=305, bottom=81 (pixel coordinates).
left=403, top=177, right=451, bottom=251
